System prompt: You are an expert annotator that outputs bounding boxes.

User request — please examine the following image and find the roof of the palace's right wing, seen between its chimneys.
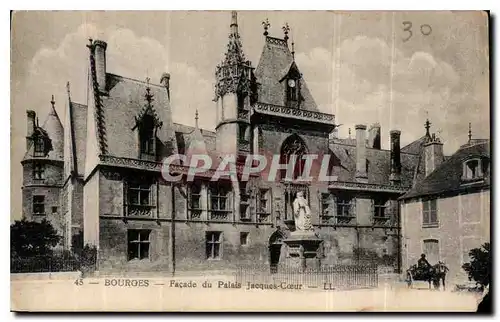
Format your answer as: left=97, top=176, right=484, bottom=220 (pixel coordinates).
left=330, top=143, right=418, bottom=187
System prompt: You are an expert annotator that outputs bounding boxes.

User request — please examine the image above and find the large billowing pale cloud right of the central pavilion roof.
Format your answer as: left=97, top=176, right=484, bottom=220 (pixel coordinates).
left=297, top=36, right=489, bottom=153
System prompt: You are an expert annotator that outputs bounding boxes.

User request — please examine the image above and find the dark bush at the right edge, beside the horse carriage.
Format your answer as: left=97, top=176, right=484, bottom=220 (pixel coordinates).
left=462, top=243, right=491, bottom=287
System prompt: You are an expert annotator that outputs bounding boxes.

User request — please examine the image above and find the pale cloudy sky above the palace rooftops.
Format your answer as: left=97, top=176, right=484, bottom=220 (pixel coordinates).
left=11, top=11, right=490, bottom=219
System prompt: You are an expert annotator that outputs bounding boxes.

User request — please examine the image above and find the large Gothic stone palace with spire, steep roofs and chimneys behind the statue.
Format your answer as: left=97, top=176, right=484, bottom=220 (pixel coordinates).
left=23, top=12, right=438, bottom=272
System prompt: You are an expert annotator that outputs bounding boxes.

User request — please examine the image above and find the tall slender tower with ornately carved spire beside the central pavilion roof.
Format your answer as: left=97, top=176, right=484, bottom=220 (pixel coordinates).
left=214, top=11, right=257, bottom=160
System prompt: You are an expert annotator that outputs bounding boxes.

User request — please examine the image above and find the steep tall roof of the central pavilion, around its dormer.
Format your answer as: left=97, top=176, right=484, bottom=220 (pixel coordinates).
left=255, top=36, right=318, bottom=112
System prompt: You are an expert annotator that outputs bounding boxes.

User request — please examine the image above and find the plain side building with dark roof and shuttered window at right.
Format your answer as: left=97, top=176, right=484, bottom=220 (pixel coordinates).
left=400, top=131, right=490, bottom=283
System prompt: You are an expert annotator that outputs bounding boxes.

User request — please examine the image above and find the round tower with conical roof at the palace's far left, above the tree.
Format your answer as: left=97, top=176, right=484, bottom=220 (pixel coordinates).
left=21, top=96, right=65, bottom=244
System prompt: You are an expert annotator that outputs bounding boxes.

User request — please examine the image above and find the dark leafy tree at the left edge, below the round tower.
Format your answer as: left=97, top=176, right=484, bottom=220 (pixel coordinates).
left=10, top=219, right=61, bottom=257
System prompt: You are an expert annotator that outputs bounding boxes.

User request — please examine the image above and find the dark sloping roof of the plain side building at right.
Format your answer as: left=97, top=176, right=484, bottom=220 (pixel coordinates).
left=401, top=141, right=490, bottom=199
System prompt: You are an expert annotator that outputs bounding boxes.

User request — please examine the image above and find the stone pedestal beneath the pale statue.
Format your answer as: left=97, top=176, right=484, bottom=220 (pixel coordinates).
left=283, top=231, right=323, bottom=272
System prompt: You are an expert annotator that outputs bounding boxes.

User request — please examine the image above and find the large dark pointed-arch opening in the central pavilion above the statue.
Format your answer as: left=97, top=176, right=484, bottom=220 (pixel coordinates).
left=280, top=134, right=307, bottom=180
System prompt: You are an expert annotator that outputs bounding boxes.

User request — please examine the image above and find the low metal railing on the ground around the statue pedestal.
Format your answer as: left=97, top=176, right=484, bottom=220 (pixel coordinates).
left=235, top=264, right=378, bottom=289
